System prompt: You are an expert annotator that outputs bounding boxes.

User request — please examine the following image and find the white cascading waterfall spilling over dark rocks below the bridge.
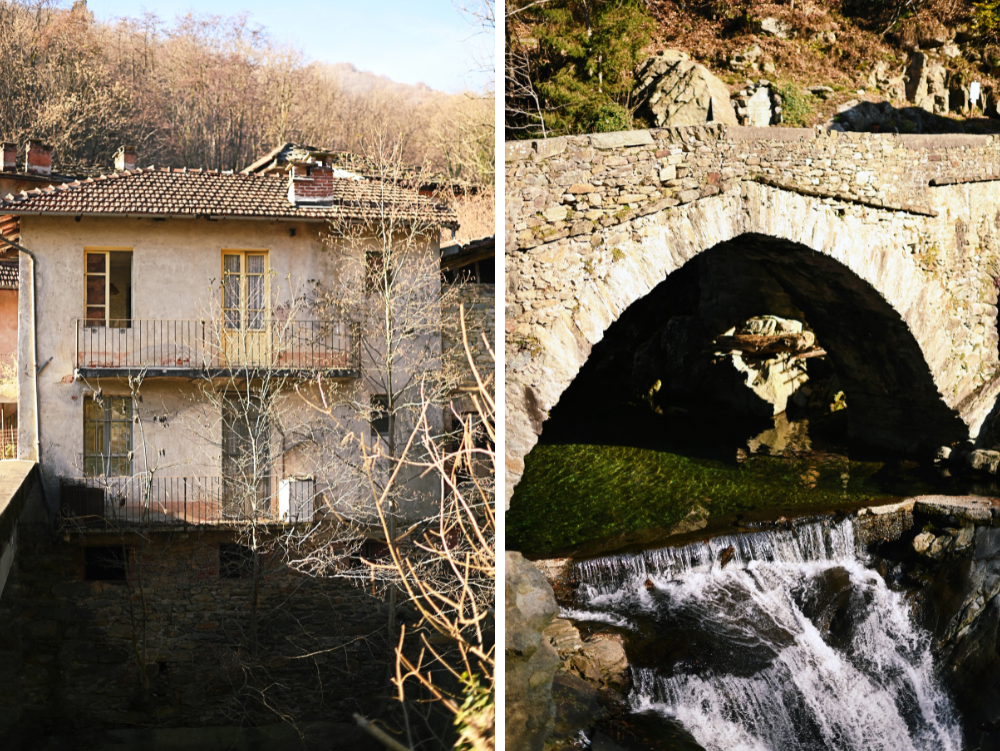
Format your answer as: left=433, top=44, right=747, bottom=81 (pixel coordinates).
left=567, top=519, right=962, bottom=751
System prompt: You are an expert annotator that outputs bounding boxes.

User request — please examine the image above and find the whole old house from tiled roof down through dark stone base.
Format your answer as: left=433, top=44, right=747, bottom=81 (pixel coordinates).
left=0, top=148, right=456, bottom=748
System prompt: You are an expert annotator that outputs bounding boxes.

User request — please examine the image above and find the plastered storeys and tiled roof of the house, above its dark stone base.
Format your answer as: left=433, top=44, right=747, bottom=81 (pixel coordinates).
left=0, top=144, right=454, bottom=522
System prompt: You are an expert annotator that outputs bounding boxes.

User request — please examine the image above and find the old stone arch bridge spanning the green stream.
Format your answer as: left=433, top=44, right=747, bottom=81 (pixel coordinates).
left=505, top=125, right=1000, bottom=502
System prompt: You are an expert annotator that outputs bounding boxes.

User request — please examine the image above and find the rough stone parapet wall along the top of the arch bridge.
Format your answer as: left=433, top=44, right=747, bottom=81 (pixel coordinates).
left=505, top=125, right=1000, bottom=250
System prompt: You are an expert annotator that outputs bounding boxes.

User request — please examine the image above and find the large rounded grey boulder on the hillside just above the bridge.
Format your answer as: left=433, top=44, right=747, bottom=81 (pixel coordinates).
left=635, top=50, right=738, bottom=128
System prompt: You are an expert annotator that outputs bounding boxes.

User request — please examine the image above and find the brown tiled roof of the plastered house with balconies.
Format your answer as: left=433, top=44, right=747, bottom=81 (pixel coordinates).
left=0, top=167, right=458, bottom=226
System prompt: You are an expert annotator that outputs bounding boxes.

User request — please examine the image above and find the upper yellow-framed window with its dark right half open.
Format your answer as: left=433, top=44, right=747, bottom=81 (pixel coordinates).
left=83, top=248, right=132, bottom=329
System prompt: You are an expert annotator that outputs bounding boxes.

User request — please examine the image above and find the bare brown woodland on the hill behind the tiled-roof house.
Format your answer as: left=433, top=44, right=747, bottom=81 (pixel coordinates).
left=0, top=0, right=495, bottom=191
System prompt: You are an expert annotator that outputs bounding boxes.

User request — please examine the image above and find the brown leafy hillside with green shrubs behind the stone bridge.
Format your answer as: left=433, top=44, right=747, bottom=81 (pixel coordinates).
left=505, top=0, right=1000, bottom=139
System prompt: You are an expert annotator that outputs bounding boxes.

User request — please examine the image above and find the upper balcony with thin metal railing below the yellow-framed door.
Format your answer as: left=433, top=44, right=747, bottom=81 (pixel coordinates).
left=74, top=318, right=361, bottom=379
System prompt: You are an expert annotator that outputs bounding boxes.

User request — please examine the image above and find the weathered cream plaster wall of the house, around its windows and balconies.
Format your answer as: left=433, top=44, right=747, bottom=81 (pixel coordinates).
left=12, top=216, right=440, bottom=516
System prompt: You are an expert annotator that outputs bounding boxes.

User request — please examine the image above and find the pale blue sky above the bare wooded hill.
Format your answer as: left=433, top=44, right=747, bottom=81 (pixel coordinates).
left=86, top=0, right=493, bottom=92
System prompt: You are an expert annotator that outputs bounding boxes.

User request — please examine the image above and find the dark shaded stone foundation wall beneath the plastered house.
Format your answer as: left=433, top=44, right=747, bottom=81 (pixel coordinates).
left=0, top=525, right=388, bottom=748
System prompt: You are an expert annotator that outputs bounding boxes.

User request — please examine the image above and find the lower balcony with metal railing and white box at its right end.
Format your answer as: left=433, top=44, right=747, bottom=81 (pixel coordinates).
left=60, top=476, right=324, bottom=531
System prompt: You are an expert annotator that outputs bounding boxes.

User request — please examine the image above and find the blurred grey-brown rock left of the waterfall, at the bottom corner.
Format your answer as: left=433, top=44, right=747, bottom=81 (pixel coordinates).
left=504, top=551, right=559, bottom=751
